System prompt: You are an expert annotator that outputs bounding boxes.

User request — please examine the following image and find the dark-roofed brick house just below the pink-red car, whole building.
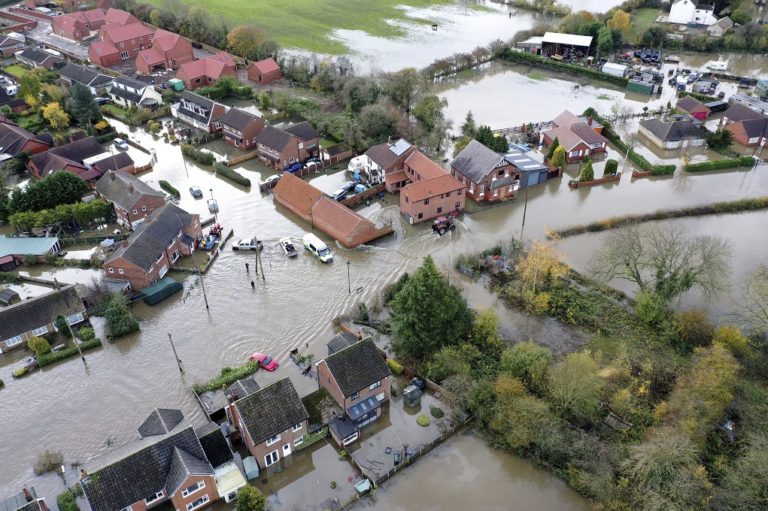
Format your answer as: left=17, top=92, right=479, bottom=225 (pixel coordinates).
left=228, top=378, right=309, bottom=468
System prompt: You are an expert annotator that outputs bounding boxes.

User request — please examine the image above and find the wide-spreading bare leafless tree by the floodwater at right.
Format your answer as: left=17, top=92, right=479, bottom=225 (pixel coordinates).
left=592, top=224, right=730, bottom=300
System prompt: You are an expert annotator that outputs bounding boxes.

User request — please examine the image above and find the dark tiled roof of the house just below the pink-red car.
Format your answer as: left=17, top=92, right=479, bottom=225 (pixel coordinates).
left=235, top=378, right=309, bottom=445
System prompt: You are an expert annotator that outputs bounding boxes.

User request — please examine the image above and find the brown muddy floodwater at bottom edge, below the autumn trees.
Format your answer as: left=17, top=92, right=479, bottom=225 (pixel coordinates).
left=352, top=433, right=592, bottom=511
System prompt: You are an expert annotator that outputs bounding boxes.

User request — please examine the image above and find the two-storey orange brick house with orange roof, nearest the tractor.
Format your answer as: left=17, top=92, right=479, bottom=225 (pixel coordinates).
left=400, top=151, right=466, bottom=224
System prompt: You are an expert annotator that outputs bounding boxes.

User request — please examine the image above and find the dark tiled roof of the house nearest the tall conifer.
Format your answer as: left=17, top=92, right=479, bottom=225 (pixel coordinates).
left=325, top=339, right=390, bottom=397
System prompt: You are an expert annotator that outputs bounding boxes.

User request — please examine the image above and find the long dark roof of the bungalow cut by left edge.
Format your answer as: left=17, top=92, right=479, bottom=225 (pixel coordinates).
left=0, top=286, right=85, bottom=341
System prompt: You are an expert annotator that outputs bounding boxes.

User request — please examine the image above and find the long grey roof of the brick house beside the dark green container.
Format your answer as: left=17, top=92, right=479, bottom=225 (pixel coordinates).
left=107, top=204, right=198, bottom=270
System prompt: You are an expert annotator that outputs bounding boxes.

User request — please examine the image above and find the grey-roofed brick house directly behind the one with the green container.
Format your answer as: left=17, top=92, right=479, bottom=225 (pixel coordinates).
left=96, top=171, right=165, bottom=229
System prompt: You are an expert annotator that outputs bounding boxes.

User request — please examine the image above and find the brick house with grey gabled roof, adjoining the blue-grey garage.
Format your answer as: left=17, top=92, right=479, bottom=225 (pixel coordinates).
left=451, top=140, right=520, bottom=202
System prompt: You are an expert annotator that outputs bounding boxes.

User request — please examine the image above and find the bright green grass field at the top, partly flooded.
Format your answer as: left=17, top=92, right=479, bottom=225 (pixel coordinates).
left=149, top=0, right=455, bottom=55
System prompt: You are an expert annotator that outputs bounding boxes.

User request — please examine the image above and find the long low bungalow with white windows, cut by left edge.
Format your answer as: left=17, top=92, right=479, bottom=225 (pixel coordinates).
left=0, top=286, right=86, bottom=353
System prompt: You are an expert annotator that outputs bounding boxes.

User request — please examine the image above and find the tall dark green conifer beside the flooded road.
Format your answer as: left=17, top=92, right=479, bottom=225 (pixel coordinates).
left=392, top=256, right=472, bottom=361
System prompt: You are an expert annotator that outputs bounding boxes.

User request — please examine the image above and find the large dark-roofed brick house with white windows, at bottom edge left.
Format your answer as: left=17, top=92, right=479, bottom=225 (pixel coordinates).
left=80, top=409, right=219, bottom=511
